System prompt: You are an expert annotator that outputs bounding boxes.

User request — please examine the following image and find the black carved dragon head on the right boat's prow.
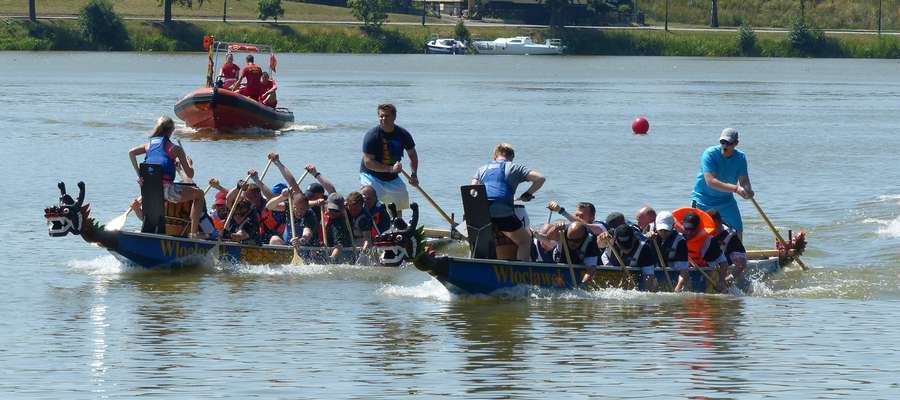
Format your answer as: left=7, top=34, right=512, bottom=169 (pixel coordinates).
left=373, top=203, right=424, bottom=267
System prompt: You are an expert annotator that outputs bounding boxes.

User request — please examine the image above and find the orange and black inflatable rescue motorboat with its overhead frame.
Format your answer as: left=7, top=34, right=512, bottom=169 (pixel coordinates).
left=175, top=37, right=294, bottom=132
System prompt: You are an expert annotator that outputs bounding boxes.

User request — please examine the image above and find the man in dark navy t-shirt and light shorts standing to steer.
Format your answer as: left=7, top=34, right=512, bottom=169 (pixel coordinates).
left=359, top=104, right=419, bottom=210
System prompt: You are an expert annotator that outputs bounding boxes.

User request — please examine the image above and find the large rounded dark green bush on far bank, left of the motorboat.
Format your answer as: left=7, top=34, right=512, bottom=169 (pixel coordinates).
left=78, top=0, right=131, bottom=50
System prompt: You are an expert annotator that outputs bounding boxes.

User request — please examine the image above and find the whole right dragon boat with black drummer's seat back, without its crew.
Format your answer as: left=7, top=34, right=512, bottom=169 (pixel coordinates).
left=377, top=185, right=806, bottom=294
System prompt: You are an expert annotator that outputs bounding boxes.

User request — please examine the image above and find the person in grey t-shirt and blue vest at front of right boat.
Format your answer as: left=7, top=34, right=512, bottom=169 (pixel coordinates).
left=472, top=143, right=545, bottom=261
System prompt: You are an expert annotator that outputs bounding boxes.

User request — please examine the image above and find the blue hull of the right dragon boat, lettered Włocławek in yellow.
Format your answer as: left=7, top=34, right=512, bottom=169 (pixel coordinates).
left=415, top=257, right=786, bottom=294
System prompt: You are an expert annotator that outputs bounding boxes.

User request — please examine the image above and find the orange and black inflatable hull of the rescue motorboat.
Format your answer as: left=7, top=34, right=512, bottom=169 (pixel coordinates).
left=175, top=87, right=294, bottom=131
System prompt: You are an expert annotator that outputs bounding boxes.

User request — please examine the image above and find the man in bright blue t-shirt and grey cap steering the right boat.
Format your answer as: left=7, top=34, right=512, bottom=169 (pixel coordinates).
left=691, top=128, right=753, bottom=237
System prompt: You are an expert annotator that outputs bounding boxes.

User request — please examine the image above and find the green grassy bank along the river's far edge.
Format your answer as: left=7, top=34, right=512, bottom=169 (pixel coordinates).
left=0, top=21, right=900, bottom=58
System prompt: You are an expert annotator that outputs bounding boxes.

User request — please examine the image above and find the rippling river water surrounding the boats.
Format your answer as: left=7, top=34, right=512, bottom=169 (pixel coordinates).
left=0, top=52, right=900, bottom=399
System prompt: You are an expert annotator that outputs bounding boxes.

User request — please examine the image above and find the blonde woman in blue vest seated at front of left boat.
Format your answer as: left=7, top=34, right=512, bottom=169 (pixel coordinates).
left=128, top=116, right=206, bottom=237
